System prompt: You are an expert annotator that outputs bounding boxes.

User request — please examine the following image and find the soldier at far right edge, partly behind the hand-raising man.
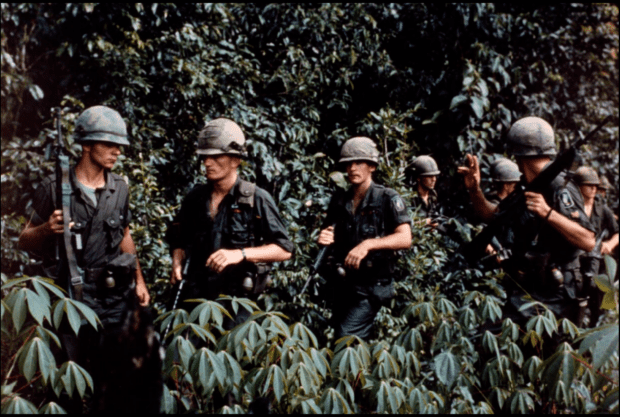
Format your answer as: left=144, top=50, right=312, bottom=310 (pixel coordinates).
left=575, top=166, right=618, bottom=326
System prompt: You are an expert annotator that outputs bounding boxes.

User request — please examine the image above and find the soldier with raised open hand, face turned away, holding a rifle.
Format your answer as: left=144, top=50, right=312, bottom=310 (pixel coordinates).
left=458, top=117, right=595, bottom=327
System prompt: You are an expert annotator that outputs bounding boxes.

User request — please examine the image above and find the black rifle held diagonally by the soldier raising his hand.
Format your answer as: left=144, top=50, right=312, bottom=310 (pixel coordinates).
left=463, top=116, right=611, bottom=259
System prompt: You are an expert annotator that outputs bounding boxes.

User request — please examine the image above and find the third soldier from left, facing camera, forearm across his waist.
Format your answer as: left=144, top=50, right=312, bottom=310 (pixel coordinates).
left=318, top=137, right=411, bottom=340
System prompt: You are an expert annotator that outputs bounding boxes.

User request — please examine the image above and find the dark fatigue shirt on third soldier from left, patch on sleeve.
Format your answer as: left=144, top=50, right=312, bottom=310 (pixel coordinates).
left=323, top=182, right=411, bottom=280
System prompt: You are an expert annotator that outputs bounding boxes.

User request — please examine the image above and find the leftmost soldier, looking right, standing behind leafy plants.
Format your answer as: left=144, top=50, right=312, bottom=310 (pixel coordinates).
left=19, top=106, right=153, bottom=410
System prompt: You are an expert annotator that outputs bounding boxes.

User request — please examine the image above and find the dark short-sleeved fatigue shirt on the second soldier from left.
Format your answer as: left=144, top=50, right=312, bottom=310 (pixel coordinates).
left=168, top=178, right=293, bottom=279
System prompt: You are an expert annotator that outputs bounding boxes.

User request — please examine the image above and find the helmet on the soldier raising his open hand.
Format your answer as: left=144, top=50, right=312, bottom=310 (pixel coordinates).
left=507, top=117, right=557, bottom=156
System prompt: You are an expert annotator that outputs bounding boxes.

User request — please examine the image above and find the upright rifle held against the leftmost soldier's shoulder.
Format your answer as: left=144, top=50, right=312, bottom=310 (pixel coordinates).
left=54, top=107, right=83, bottom=301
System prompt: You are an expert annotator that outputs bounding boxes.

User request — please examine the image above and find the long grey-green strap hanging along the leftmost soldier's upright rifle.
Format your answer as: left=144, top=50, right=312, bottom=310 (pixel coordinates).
left=58, top=155, right=83, bottom=301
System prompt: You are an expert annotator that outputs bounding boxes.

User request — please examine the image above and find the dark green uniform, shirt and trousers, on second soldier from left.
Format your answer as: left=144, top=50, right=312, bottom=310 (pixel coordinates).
left=169, top=179, right=293, bottom=299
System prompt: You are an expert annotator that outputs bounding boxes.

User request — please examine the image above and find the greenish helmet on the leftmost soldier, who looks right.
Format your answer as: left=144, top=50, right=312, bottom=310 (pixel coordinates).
left=73, top=106, right=129, bottom=145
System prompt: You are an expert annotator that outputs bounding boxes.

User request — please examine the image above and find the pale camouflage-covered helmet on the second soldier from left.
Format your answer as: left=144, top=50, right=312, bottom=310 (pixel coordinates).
left=196, top=118, right=248, bottom=157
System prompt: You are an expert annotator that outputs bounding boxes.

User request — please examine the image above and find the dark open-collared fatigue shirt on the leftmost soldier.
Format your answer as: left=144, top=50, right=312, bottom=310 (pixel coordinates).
left=31, top=168, right=131, bottom=269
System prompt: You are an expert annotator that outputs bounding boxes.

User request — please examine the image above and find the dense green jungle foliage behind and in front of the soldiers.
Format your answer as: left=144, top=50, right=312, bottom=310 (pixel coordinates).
left=1, top=3, right=619, bottom=412
